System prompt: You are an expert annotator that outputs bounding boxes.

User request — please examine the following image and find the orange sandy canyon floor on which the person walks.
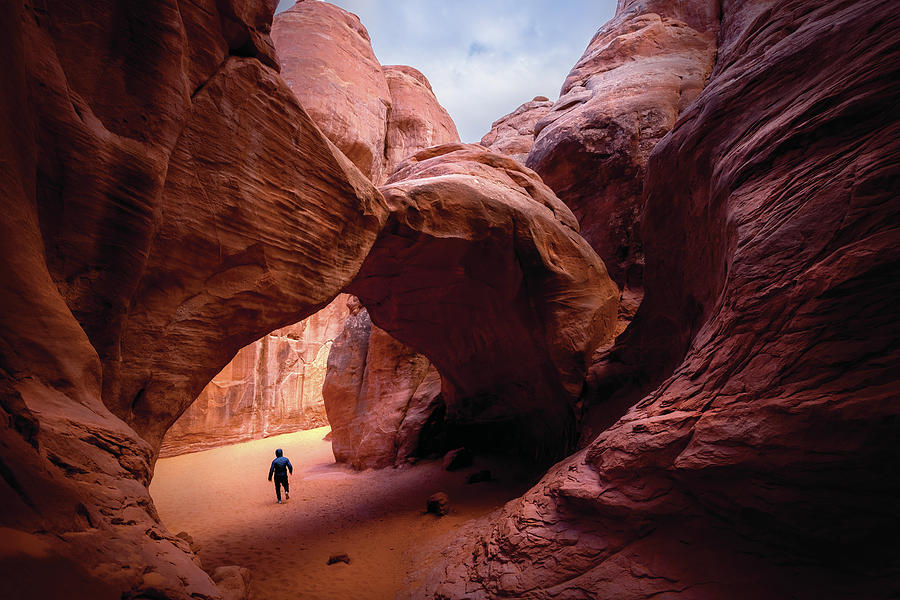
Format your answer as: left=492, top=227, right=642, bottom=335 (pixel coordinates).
left=150, top=427, right=529, bottom=600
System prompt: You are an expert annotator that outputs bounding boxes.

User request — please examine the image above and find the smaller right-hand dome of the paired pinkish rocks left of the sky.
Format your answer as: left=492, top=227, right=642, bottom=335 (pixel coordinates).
left=383, top=65, right=459, bottom=178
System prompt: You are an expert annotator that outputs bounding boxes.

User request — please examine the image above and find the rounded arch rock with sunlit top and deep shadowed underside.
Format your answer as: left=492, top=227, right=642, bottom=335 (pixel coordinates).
left=348, top=144, right=618, bottom=458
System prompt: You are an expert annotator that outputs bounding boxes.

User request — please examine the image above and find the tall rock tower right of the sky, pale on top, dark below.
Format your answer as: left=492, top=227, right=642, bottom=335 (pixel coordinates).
left=525, top=0, right=719, bottom=296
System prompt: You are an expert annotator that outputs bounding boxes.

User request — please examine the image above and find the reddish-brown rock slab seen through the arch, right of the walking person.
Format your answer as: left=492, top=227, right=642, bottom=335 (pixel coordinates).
left=322, top=296, right=443, bottom=469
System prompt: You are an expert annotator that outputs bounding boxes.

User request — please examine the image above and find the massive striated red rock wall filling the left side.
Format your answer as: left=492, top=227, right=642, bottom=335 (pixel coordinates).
left=0, top=0, right=386, bottom=600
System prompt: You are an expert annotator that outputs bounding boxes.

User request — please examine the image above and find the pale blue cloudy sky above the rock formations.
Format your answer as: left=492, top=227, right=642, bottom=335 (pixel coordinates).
left=270, top=0, right=616, bottom=142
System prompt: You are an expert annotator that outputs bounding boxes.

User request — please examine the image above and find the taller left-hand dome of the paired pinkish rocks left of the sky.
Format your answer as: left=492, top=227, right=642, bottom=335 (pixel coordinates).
left=272, top=0, right=391, bottom=183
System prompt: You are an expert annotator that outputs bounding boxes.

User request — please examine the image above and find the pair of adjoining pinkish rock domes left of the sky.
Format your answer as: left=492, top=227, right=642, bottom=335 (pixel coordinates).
left=272, top=0, right=459, bottom=184
